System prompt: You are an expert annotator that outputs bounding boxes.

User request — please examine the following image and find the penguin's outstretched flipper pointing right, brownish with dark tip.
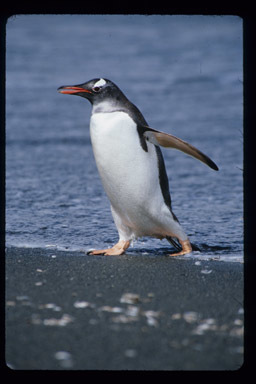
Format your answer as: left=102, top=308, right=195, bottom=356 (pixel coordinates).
left=143, top=127, right=219, bottom=171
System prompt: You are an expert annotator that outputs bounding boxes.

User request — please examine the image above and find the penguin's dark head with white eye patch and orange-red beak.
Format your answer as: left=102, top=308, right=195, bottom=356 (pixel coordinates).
left=58, top=78, right=124, bottom=105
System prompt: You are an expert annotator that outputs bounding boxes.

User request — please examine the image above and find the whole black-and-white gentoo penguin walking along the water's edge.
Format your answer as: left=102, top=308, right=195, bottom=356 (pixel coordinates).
left=58, top=78, right=218, bottom=256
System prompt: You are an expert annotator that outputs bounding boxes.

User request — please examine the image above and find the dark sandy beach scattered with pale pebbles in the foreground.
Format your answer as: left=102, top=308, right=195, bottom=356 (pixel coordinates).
left=6, top=248, right=243, bottom=371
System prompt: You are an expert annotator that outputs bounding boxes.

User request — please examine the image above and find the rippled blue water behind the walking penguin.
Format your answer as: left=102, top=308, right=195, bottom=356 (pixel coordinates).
left=6, top=15, right=243, bottom=261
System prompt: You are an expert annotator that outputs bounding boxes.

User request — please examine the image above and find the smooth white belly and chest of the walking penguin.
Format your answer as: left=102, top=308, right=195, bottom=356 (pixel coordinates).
left=90, top=112, right=184, bottom=237
